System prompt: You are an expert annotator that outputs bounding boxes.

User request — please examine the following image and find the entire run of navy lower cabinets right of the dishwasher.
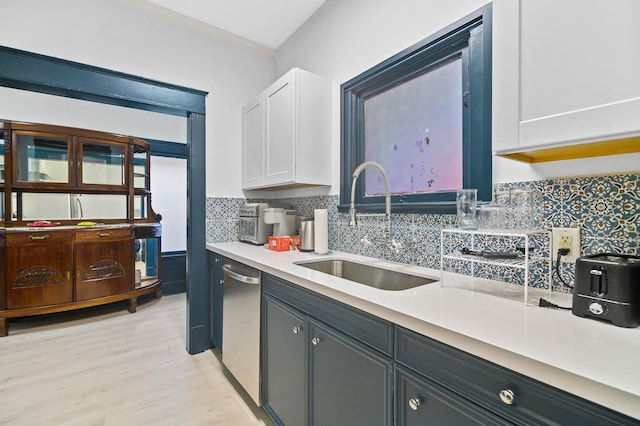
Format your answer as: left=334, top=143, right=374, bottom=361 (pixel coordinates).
left=262, top=274, right=639, bottom=426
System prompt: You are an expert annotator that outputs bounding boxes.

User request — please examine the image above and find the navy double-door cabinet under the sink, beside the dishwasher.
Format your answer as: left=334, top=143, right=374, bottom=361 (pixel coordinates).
left=262, top=274, right=393, bottom=426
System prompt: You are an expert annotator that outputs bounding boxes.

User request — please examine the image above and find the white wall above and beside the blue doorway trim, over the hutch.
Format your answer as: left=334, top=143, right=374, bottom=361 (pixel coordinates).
left=0, top=0, right=274, bottom=197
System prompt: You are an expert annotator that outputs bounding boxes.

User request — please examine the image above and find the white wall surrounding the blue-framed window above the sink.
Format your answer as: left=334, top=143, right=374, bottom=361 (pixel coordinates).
left=275, top=0, right=640, bottom=196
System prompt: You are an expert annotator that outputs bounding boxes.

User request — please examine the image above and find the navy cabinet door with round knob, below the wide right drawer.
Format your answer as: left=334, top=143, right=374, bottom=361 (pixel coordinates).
left=394, top=368, right=512, bottom=426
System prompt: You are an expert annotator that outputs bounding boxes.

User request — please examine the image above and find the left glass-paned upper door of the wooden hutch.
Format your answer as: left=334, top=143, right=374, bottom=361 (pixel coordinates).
left=13, top=132, right=73, bottom=184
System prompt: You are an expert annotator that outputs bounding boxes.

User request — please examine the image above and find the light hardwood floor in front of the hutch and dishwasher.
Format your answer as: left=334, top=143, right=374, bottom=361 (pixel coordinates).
left=0, top=294, right=273, bottom=426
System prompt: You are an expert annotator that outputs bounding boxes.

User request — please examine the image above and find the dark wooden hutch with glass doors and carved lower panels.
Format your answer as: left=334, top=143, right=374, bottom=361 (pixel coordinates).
left=0, top=121, right=162, bottom=336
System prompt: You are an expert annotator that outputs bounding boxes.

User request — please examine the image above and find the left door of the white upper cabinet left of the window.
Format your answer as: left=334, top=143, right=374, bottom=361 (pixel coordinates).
left=242, top=96, right=265, bottom=188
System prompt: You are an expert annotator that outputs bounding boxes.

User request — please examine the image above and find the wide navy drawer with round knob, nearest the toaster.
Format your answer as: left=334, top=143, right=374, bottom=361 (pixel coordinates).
left=396, top=327, right=638, bottom=426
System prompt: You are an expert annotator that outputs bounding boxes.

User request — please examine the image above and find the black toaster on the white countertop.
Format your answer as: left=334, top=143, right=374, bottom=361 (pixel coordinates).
left=572, top=253, right=640, bottom=327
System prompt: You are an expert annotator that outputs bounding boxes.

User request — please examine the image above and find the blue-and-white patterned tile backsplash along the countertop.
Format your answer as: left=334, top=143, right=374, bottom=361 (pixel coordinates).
left=207, top=172, right=640, bottom=290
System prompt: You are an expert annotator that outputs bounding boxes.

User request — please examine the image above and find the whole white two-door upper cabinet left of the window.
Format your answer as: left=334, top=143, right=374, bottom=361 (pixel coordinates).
left=242, top=68, right=331, bottom=189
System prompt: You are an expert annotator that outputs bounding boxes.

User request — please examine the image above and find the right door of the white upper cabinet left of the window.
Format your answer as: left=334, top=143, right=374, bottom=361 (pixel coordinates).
left=265, top=73, right=297, bottom=184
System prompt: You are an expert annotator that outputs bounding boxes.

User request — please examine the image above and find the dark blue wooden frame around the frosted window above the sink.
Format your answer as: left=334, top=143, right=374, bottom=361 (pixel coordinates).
left=339, top=4, right=492, bottom=213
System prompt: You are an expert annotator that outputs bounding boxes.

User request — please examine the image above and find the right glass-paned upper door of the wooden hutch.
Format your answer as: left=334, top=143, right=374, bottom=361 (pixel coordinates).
left=78, top=140, right=126, bottom=186
